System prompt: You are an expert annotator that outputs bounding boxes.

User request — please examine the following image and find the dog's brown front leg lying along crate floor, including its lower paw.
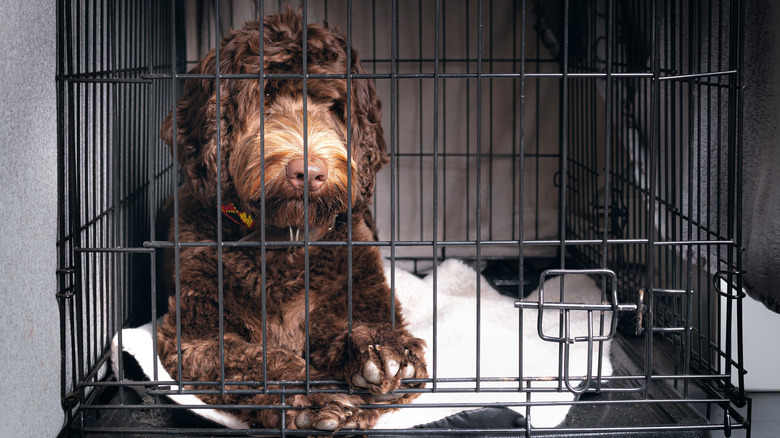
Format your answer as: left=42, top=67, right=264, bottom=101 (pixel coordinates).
left=158, top=312, right=378, bottom=431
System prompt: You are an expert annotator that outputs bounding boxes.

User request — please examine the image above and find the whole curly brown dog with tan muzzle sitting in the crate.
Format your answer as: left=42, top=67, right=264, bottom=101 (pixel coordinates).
left=158, top=10, right=427, bottom=430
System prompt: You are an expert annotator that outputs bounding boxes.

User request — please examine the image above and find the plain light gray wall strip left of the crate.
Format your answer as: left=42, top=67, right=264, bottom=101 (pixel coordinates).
left=0, top=0, right=63, bottom=437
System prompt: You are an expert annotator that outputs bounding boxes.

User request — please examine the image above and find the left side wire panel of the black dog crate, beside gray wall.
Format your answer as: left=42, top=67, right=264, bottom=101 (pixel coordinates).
left=57, top=2, right=175, bottom=428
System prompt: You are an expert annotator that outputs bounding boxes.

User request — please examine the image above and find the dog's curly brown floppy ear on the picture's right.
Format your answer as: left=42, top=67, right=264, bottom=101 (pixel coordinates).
left=351, top=50, right=389, bottom=203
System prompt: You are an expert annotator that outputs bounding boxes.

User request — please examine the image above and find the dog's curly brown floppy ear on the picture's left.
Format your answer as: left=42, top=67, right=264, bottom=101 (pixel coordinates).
left=160, top=50, right=219, bottom=203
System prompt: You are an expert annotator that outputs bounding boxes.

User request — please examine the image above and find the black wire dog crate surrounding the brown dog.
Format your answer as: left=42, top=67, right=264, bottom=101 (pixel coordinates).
left=57, top=0, right=750, bottom=436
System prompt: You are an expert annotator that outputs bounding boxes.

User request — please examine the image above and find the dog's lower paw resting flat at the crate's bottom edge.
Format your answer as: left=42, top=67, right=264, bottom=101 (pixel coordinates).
left=293, top=401, right=379, bottom=432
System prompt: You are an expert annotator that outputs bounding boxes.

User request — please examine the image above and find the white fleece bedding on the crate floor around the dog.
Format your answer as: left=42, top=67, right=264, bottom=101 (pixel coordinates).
left=111, top=259, right=612, bottom=429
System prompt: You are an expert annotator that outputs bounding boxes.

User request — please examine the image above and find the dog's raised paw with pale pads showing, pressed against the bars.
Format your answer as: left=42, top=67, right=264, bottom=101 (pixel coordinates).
left=347, top=326, right=428, bottom=402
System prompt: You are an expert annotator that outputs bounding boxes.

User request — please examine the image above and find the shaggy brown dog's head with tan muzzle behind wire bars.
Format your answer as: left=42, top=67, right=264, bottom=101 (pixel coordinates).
left=161, top=10, right=387, bottom=233
